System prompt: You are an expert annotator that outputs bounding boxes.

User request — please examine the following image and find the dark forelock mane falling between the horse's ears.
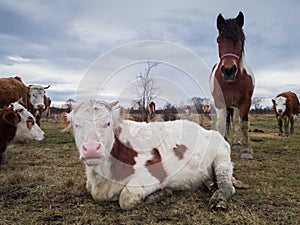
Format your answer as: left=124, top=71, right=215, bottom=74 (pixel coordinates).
left=219, top=19, right=245, bottom=51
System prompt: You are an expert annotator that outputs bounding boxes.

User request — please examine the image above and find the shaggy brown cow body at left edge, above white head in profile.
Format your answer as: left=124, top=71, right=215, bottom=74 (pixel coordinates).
left=0, top=77, right=29, bottom=108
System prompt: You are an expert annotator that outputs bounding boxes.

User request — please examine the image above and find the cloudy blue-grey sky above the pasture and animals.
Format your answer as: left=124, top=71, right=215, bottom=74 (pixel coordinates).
left=0, top=0, right=300, bottom=107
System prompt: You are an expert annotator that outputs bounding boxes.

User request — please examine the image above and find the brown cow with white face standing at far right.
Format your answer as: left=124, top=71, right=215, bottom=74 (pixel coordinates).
left=272, top=91, right=299, bottom=136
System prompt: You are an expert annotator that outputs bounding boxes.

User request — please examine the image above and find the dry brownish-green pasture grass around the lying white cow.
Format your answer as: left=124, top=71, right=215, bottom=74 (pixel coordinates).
left=0, top=115, right=300, bottom=225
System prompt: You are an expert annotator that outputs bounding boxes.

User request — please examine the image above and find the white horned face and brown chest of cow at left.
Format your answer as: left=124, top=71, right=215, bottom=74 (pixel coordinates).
left=28, top=85, right=50, bottom=126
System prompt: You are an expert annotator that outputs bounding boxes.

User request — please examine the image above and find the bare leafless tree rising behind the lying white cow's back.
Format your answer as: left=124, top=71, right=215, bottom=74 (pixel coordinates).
left=133, top=61, right=159, bottom=121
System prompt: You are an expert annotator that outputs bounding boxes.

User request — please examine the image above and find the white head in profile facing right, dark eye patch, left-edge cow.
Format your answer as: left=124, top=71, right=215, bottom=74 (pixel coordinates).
left=9, top=102, right=45, bottom=141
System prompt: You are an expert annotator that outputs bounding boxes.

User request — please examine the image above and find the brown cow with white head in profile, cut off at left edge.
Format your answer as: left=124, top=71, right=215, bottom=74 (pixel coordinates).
left=0, top=102, right=45, bottom=164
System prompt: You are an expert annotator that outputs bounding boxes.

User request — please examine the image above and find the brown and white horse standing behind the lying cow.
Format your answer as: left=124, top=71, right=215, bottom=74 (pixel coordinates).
left=210, top=12, right=254, bottom=159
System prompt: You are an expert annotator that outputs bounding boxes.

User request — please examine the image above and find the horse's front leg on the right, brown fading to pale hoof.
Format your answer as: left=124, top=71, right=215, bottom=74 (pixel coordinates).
left=240, top=101, right=253, bottom=159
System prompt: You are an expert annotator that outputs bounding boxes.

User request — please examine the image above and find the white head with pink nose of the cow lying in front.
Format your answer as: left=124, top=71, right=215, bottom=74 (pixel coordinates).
left=66, top=100, right=120, bottom=166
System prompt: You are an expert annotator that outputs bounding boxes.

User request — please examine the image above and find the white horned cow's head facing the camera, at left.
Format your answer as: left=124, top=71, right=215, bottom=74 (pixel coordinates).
left=29, top=85, right=50, bottom=111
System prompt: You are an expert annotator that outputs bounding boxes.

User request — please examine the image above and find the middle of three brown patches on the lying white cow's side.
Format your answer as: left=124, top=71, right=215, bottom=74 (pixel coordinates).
left=145, top=148, right=167, bottom=183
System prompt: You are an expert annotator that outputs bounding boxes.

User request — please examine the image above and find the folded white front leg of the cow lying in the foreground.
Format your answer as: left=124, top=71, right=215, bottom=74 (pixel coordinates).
left=119, top=174, right=161, bottom=210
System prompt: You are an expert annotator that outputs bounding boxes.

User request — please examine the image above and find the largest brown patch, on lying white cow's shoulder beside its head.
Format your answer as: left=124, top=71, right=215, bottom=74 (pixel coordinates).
left=110, top=135, right=138, bottom=181
